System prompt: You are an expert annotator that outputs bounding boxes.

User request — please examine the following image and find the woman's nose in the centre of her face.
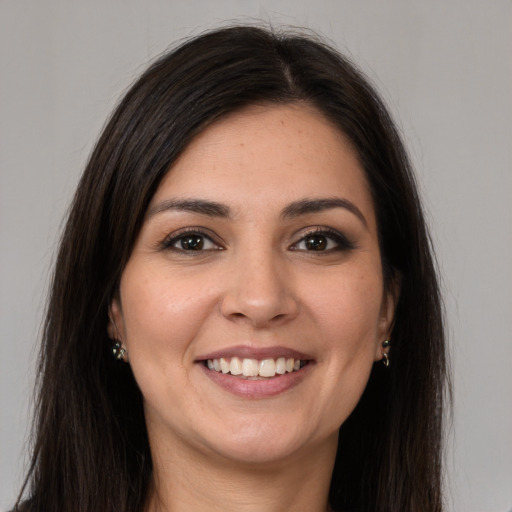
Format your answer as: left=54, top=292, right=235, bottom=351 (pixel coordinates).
left=221, top=248, right=299, bottom=328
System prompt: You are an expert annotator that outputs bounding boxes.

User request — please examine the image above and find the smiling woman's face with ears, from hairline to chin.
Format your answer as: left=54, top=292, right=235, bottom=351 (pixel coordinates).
left=111, top=105, right=394, bottom=462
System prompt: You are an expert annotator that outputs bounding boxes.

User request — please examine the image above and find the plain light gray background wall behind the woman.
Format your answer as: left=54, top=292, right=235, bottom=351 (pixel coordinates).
left=0, top=0, right=512, bottom=512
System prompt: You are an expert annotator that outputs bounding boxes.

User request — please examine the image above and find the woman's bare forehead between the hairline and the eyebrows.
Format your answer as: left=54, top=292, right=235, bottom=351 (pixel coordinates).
left=152, top=104, right=373, bottom=225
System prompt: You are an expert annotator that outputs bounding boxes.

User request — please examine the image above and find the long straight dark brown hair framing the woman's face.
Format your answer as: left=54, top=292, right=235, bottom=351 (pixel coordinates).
left=16, top=26, right=446, bottom=512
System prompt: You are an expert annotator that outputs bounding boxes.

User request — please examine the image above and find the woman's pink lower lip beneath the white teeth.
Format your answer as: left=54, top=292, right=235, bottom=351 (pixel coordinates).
left=201, top=363, right=312, bottom=398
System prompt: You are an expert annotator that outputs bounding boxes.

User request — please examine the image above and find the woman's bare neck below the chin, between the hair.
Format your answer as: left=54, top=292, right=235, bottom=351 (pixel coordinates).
left=146, top=430, right=337, bottom=512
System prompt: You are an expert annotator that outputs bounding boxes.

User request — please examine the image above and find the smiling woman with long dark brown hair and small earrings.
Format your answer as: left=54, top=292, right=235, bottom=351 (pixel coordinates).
left=14, top=27, right=445, bottom=512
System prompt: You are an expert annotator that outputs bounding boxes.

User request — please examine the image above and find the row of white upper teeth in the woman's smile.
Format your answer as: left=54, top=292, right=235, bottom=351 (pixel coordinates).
left=206, top=357, right=301, bottom=377
